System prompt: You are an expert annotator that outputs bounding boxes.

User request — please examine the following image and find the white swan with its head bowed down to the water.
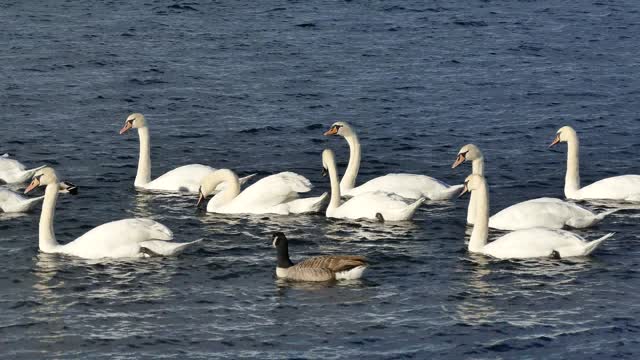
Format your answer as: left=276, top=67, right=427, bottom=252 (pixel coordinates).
left=198, top=169, right=328, bottom=215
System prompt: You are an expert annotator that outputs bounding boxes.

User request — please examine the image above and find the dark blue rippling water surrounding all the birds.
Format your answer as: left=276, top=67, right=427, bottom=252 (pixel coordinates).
left=0, top=0, right=640, bottom=359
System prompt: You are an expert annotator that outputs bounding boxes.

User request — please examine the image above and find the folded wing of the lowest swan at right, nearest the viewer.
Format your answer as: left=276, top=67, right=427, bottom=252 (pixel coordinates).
left=482, top=228, right=586, bottom=259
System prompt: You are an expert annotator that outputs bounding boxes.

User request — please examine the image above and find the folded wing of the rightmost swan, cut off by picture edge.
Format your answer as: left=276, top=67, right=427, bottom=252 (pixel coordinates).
left=579, top=175, right=640, bottom=200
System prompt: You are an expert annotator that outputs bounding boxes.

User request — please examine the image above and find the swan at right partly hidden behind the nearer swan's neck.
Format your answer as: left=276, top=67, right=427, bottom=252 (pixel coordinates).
left=452, top=144, right=620, bottom=230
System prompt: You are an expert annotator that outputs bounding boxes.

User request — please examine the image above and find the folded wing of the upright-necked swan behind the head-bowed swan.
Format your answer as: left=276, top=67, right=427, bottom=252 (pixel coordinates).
left=144, top=164, right=216, bottom=193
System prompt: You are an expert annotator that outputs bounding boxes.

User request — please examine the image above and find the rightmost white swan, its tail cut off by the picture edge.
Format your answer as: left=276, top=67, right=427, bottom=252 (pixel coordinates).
left=549, top=126, right=640, bottom=201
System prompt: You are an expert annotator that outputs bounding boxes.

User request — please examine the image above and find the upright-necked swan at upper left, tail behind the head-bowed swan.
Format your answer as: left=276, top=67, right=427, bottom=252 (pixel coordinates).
left=120, top=113, right=255, bottom=193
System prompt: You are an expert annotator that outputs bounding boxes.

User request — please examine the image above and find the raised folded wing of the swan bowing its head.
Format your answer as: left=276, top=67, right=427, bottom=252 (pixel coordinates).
left=233, top=172, right=311, bottom=208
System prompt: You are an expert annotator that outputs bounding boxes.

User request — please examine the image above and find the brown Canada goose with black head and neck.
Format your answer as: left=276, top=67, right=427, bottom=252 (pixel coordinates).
left=272, top=232, right=367, bottom=281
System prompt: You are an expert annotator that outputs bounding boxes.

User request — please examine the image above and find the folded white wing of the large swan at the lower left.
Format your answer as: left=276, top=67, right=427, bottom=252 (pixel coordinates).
left=60, top=219, right=173, bottom=259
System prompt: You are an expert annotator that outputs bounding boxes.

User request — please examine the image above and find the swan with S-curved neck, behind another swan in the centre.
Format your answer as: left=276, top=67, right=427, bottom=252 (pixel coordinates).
left=324, top=121, right=462, bottom=200
